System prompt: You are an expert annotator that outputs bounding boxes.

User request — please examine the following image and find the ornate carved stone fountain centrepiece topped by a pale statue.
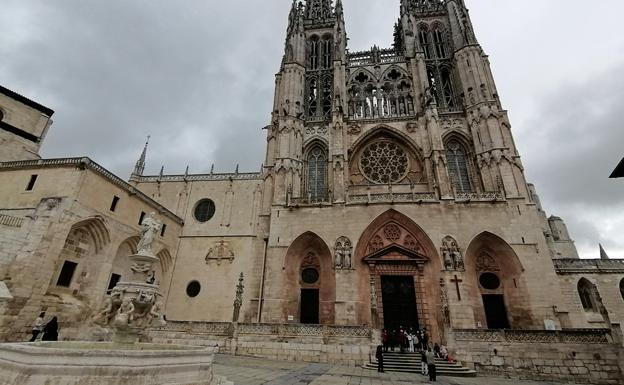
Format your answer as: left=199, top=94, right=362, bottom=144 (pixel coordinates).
left=93, top=213, right=166, bottom=343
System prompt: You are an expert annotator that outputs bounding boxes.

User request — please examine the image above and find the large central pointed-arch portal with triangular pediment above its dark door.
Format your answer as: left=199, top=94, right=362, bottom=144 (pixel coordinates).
left=355, top=210, right=444, bottom=341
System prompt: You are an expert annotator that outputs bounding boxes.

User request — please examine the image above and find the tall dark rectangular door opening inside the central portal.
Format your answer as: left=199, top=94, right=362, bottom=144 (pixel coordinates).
left=381, top=275, right=420, bottom=330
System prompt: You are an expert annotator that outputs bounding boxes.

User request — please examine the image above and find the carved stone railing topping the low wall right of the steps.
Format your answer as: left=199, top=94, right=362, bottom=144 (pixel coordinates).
left=455, top=329, right=613, bottom=344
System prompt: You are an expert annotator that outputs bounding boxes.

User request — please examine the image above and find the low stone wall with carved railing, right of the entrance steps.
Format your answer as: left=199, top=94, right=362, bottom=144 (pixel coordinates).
left=453, top=329, right=624, bottom=384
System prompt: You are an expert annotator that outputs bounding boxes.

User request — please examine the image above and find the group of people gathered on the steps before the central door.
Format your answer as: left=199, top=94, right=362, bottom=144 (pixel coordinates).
left=375, top=327, right=453, bottom=381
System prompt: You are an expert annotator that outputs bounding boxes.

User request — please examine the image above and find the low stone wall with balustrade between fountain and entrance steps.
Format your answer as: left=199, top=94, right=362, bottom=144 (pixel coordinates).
left=150, top=322, right=372, bottom=366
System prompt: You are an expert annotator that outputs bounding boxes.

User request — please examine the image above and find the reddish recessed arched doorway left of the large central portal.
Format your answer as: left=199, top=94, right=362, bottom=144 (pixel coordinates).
left=282, top=232, right=336, bottom=325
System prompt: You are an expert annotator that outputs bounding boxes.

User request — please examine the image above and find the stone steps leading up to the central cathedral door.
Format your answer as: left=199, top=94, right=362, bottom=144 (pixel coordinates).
left=363, top=352, right=477, bottom=377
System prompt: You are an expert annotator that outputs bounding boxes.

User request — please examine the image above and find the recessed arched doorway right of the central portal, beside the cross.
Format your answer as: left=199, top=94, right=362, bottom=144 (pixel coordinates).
left=465, top=232, right=541, bottom=329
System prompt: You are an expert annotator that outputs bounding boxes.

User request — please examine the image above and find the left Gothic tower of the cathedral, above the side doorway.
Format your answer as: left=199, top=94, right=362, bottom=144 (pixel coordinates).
left=265, top=0, right=347, bottom=207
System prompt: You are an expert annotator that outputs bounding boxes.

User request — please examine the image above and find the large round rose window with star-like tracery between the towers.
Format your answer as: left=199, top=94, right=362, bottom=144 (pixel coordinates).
left=360, top=140, right=409, bottom=184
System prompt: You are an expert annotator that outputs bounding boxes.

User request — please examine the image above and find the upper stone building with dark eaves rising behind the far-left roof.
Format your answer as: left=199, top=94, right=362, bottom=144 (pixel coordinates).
left=0, top=86, right=54, bottom=162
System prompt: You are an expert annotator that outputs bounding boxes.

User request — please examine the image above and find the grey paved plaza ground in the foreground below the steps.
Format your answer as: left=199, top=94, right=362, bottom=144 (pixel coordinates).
left=214, top=355, right=560, bottom=385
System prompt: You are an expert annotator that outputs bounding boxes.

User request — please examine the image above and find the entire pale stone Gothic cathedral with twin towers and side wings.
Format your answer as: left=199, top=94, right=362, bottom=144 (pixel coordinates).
left=0, top=0, right=624, bottom=372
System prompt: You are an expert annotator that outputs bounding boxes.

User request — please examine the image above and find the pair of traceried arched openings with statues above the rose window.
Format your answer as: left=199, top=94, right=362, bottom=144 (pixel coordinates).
left=348, top=68, right=414, bottom=119
